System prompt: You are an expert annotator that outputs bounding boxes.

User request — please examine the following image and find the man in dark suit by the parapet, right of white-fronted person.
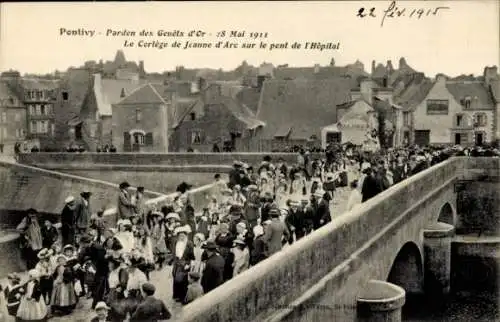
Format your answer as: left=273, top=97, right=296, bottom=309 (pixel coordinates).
left=201, top=240, right=225, bottom=294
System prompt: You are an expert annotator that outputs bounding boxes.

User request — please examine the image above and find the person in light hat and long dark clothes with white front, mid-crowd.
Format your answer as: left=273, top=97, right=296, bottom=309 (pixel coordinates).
left=172, top=225, right=196, bottom=302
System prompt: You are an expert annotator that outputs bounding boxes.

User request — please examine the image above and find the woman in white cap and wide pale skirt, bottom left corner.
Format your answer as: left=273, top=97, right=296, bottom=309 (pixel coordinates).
left=16, top=269, right=48, bottom=322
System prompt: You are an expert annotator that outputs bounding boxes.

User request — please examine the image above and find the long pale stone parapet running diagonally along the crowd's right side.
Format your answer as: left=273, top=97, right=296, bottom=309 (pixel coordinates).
left=183, top=158, right=463, bottom=322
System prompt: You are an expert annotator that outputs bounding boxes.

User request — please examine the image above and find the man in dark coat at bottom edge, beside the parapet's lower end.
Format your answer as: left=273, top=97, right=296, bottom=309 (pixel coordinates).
left=129, top=283, right=172, bottom=322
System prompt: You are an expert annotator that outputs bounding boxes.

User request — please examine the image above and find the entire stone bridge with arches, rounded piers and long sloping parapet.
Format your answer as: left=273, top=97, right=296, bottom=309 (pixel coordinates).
left=183, top=158, right=500, bottom=322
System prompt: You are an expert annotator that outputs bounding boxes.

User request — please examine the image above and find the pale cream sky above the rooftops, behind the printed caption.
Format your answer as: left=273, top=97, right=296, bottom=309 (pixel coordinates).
left=0, top=0, right=500, bottom=76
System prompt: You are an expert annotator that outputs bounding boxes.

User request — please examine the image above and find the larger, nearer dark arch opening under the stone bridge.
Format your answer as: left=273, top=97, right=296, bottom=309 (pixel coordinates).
left=387, top=241, right=424, bottom=294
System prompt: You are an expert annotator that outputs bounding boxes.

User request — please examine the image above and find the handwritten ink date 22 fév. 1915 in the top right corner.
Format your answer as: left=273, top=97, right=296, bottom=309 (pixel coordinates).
left=356, top=1, right=450, bottom=27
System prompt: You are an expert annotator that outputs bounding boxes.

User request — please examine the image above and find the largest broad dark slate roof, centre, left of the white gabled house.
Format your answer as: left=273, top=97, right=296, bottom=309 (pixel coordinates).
left=256, top=78, right=350, bottom=139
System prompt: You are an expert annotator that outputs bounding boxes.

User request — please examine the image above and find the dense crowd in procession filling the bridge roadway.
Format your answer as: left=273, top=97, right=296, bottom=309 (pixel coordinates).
left=4, top=143, right=498, bottom=321
